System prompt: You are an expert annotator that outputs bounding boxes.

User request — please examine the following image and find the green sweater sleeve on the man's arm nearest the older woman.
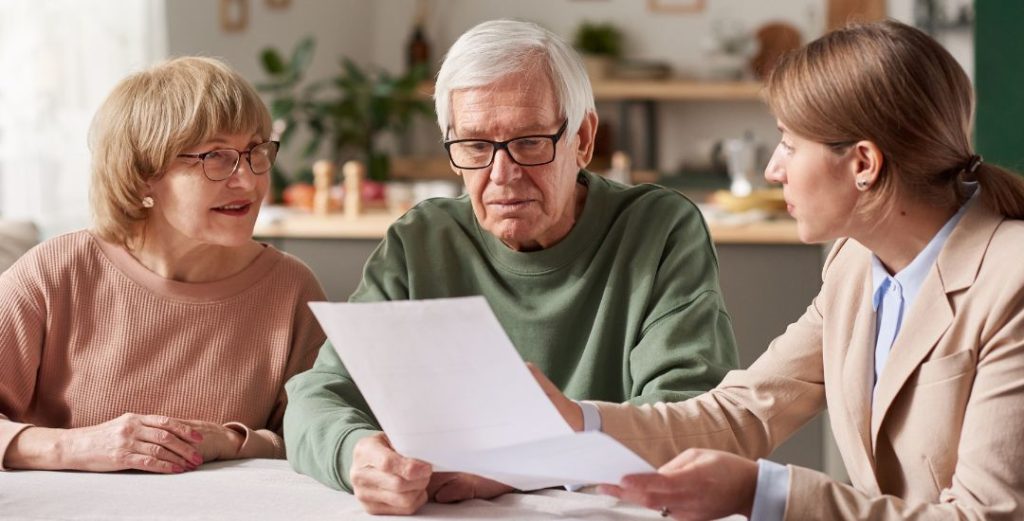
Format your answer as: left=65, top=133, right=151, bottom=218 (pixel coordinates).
left=285, top=227, right=409, bottom=491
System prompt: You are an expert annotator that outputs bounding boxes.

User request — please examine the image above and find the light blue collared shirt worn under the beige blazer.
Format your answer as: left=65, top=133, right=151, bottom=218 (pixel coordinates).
left=751, top=195, right=977, bottom=521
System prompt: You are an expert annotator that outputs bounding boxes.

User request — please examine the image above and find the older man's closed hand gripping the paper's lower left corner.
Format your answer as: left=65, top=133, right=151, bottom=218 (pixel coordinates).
left=348, top=433, right=433, bottom=516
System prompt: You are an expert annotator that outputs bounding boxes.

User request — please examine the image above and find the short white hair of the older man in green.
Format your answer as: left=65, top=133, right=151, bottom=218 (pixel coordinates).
left=434, top=19, right=596, bottom=136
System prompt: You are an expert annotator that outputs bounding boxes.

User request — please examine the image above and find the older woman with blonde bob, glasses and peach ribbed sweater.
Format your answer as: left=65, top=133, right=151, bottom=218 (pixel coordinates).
left=0, top=57, right=324, bottom=473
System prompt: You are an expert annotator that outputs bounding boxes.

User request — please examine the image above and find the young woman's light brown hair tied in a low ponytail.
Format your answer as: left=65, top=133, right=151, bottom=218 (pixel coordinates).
left=767, top=20, right=1024, bottom=219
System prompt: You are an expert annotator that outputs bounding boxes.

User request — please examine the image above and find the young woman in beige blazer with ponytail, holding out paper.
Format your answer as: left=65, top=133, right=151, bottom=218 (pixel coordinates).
left=547, top=21, right=1024, bottom=520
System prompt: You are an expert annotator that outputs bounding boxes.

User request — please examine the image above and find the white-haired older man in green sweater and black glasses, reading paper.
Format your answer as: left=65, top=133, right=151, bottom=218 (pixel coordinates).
left=285, top=20, right=736, bottom=514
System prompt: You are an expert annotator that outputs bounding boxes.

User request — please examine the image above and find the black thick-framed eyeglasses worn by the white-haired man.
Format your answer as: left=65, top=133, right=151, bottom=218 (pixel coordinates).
left=444, top=120, right=569, bottom=170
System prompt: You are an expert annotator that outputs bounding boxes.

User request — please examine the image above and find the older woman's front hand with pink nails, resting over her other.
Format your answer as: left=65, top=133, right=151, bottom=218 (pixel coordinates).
left=57, top=414, right=203, bottom=474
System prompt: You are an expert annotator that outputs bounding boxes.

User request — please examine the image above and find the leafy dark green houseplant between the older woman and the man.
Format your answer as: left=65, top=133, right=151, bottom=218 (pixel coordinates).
left=257, top=37, right=433, bottom=202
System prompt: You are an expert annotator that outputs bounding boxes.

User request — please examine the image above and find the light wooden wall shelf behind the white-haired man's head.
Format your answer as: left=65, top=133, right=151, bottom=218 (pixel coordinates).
left=419, top=79, right=763, bottom=101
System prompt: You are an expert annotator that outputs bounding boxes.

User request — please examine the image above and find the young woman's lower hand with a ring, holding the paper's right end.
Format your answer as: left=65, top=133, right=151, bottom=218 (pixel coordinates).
left=598, top=448, right=758, bottom=521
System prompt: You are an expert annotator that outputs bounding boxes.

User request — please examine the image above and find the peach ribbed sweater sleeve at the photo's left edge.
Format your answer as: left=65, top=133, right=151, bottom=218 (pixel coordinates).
left=0, top=258, right=46, bottom=470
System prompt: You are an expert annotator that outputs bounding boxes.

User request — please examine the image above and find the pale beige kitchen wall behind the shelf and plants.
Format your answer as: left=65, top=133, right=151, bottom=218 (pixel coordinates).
left=167, top=0, right=973, bottom=177
